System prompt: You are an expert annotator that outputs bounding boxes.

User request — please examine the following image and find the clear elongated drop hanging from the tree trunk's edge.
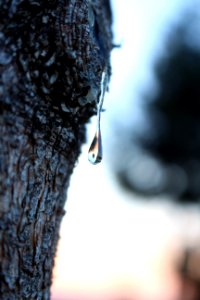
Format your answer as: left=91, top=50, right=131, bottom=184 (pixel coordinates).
left=88, top=70, right=107, bottom=165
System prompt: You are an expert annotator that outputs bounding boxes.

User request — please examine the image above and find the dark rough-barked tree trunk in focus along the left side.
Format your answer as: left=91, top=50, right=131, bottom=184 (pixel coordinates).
left=0, top=0, right=112, bottom=300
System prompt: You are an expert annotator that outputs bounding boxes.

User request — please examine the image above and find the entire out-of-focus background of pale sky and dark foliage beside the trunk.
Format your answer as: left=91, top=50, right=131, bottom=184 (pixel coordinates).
left=52, top=0, right=200, bottom=300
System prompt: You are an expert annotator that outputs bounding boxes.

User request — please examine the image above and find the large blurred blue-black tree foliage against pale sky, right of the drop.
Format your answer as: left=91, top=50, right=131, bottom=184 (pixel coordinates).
left=116, top=16, right=200, bottom=203
